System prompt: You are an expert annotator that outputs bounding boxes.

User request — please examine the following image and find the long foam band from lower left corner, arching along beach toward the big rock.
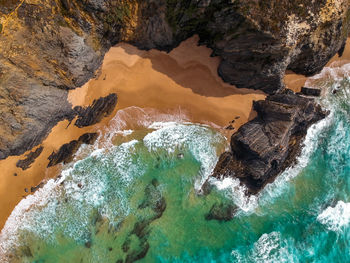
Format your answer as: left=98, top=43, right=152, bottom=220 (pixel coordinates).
left=0, top=122, right=225, bottom=262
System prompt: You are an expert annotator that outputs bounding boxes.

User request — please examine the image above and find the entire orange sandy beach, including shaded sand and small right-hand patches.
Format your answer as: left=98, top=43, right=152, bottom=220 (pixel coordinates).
left=0, top=36, right=350, bottom=231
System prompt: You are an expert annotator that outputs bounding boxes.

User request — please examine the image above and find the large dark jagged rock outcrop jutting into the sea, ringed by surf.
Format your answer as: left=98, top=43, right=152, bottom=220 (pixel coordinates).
left=212, top=90, right=326, bottom=194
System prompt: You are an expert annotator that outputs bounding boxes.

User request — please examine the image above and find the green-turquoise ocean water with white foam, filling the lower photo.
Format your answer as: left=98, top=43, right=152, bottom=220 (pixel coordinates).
left=0, top=65, right=350, bottom=263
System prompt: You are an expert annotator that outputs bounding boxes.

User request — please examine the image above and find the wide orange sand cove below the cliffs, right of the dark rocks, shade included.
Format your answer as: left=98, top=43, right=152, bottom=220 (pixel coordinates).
left=69, top=37, right=265, bottom=129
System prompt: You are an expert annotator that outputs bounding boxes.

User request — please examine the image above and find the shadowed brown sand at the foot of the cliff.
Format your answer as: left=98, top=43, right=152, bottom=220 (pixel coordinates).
left=117, top=37, right=264, bottom=97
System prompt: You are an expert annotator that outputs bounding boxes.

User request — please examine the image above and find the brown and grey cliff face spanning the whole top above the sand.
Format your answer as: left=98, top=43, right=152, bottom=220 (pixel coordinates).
left=0, top=0, right=350, bottom=159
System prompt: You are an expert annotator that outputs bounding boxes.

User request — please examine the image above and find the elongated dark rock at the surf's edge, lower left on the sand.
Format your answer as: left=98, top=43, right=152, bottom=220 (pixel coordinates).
left=47, top=133, right=98, bottom=167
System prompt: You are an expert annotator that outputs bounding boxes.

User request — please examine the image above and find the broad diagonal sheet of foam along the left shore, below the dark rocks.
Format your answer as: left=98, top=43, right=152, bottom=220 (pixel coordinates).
left=0, top=140, right=142, bottom=262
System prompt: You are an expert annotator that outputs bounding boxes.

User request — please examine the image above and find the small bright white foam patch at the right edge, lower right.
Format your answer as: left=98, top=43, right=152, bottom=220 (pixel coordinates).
left=317, top=201, right=350, bottom=231
